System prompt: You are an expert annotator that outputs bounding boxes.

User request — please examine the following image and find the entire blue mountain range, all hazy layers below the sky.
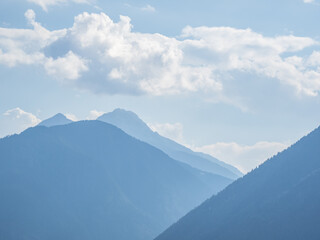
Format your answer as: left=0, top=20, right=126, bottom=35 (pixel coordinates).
left=0, top=109, right=320, bottom=240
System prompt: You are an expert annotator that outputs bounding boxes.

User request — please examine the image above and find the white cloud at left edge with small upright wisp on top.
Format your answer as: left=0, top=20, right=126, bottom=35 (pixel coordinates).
left=0, top=9, right=88, bottom=80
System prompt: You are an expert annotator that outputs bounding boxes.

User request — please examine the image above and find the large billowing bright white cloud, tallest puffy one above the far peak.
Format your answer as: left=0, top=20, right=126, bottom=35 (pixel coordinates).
left=70, top=13, right=221, bottom=95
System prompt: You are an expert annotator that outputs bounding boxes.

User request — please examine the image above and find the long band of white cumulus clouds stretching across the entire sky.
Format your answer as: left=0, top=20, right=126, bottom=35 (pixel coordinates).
left=0, top=10, right=320, bottom=99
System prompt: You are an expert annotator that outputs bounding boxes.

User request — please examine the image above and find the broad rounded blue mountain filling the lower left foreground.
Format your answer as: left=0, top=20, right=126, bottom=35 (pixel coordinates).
left=0, top=121, right=231, bottom=240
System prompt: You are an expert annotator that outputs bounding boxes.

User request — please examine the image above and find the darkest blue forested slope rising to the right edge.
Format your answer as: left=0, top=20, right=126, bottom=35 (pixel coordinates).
left=156, top=125, right=320, bottom=240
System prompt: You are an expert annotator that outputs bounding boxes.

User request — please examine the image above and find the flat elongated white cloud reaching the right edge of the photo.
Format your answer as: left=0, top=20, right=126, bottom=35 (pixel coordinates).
left=182, top=27, right=320, bottom=96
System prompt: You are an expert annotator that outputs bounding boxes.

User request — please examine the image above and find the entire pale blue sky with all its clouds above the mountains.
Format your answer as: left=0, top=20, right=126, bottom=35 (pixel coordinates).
left=0, top=0, right=320, bottom=172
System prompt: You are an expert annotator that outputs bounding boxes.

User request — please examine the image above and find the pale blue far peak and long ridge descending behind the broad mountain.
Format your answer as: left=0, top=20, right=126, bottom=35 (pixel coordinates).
left=98, top=109, right=243, bottom=179
